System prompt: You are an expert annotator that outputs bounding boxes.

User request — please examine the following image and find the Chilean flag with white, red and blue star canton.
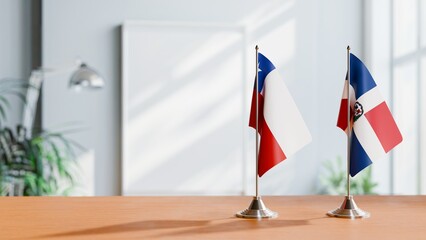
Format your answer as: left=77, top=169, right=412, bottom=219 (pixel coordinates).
left=249, top=53, right=311, bottom=177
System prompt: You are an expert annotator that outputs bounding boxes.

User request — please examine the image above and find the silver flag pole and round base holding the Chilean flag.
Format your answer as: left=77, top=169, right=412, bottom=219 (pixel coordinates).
left=236, top=45, right=278, bottom=219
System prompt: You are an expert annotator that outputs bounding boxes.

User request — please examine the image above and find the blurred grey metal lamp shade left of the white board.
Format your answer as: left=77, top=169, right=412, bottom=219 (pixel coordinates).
left=69, top=63, right=105, bottom=89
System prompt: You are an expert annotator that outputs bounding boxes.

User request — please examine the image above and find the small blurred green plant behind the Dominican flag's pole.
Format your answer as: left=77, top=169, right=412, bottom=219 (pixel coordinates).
left=320, top=157, right=378, bottom=195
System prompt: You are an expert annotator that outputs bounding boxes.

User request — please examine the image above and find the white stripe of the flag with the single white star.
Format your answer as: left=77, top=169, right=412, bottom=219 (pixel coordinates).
left=263, top=70, right=312, bottom=157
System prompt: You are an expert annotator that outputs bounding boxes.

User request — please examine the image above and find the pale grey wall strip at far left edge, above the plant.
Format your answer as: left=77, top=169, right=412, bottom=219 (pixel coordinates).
left=0, top=0, right=31, bottom=128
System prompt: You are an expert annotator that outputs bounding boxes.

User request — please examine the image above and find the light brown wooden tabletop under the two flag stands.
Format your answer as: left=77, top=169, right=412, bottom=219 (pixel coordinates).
left=0, top=196, right=426, bottom=240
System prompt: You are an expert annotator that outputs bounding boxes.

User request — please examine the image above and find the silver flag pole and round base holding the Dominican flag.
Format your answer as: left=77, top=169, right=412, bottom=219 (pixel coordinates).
left=327, top=46, right=370, bottom=219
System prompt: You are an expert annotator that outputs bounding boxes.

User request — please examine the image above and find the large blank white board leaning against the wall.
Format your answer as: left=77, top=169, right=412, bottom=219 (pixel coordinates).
left=122, top=22, right=246, bottom=195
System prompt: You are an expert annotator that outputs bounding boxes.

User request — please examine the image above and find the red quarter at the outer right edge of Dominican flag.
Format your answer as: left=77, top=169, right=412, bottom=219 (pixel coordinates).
left=364, top=102, right=402, bottom=152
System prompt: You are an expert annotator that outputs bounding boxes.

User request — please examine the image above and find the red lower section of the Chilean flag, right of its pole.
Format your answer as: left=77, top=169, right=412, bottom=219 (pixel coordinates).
left=258, top=122, right=287, bottom=177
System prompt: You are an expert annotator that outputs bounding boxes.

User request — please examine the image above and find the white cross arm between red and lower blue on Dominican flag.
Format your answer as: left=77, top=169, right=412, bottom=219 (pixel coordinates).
left=353, top=115, right=386, bottom=161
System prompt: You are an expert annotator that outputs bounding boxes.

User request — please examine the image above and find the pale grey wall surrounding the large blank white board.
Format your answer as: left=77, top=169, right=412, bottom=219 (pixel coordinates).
left=42, top=0, right=363, bottom=195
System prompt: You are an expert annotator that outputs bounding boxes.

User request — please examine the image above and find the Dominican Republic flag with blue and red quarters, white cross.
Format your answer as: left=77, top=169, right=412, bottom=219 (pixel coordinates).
left=337, top=54, right=402, bottom=177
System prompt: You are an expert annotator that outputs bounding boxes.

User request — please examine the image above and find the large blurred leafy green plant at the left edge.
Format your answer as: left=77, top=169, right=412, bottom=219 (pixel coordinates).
left=0, top=80, right=81, bottom=196
